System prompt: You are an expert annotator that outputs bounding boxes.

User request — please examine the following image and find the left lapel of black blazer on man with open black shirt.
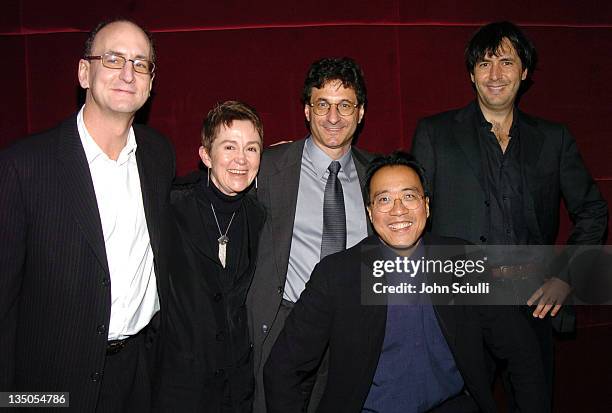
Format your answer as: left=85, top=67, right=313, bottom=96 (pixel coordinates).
left=452, top=103, right=485, bottom=189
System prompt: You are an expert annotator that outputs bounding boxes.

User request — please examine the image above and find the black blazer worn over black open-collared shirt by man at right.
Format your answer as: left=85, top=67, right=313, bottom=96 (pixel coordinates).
left=412, top=102, right=608, bottom=256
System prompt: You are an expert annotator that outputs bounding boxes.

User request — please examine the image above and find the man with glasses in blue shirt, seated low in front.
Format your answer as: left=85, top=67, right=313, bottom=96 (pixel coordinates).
left=264, top=152, right=549, bottom=413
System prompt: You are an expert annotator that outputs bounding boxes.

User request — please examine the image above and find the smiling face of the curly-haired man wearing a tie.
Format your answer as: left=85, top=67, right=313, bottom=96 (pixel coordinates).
left=304, top=80, right=364, bottom=159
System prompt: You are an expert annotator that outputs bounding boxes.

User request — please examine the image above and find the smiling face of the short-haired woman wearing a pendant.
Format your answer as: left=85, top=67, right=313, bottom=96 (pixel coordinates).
left=199, top=120, right=262, bottom=196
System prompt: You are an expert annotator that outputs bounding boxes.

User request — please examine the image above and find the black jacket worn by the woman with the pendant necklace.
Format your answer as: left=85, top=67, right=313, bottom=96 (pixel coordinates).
left=158, top=174, right=265, bottom=412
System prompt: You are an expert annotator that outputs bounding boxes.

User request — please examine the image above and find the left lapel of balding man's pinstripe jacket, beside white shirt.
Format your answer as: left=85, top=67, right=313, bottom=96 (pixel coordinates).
left=57, top=116, right=110, bottom=274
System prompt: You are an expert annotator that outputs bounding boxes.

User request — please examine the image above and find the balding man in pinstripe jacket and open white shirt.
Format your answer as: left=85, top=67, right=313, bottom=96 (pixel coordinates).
left=0, top=19, right=175, bottom=412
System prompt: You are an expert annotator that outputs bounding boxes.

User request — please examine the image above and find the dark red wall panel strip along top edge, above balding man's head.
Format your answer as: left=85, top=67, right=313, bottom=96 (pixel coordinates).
left=21, top=0, right=398, bottom=31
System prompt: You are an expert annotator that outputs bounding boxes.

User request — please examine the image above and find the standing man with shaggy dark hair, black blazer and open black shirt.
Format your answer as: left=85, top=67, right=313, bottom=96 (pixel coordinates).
left=412, top=22, right=607, bottom=408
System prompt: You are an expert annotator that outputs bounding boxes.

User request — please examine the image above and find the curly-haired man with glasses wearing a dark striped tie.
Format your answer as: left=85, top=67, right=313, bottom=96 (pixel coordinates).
left=247, top=58, right=370, bottom=413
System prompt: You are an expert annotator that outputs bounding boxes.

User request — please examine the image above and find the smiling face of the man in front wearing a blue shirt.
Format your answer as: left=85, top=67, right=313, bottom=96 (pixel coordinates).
left=368, top=165, right=429, bottom=249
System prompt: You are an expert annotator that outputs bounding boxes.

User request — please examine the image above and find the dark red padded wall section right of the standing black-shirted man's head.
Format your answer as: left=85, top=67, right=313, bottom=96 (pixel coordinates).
left=521, top=28, right=612, bottom=178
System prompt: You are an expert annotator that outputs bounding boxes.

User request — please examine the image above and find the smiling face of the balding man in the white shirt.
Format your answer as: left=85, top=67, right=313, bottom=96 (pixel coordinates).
left=78, top=21, right=153, bottom=116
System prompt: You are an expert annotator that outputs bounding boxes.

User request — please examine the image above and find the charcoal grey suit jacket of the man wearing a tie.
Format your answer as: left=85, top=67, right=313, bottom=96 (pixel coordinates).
left=247, top=139, right=372, bottom=374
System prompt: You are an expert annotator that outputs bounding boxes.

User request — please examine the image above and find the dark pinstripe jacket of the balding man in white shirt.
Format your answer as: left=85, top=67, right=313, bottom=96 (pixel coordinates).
left=0, top=116, right=174, bottom=411
